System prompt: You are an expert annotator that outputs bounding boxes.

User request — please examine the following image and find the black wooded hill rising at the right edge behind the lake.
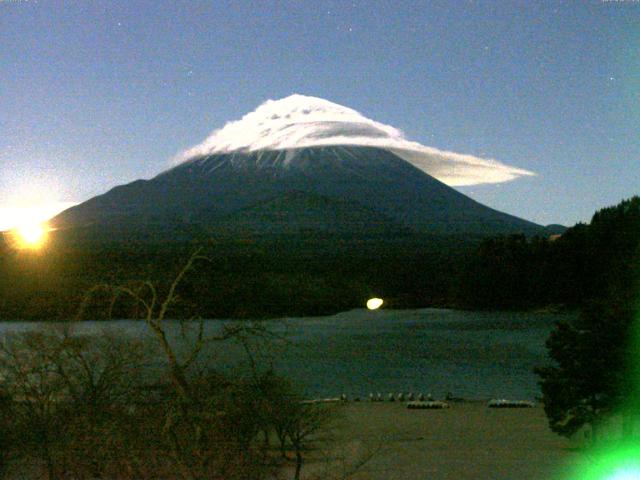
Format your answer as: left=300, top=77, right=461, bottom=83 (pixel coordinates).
left=458, top=197, right=640, bottom=309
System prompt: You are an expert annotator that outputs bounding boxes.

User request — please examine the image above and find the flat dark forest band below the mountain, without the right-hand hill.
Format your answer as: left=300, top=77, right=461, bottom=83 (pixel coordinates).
left=0, top=236, right=470, bottom=320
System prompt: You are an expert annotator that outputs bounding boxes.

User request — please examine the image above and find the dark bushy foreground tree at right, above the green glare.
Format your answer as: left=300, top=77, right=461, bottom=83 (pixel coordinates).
left=536, top=301, right=634, bottom=441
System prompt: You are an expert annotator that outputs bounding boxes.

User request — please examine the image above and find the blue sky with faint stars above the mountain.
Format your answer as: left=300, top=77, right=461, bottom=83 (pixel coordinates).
left=0, top=0, right=640, bottom=229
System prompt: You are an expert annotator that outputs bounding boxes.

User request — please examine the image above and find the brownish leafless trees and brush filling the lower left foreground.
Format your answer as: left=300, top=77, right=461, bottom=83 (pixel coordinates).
left=0, top=252, right=380, bottom=480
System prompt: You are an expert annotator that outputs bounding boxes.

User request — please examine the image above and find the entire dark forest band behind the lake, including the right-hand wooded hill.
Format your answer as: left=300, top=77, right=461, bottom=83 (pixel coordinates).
left=0, top=197, right=640, bottom=320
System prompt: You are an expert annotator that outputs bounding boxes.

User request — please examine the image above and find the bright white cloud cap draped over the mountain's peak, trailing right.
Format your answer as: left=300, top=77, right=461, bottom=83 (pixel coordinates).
left=178, top=94, right=533, bottom=186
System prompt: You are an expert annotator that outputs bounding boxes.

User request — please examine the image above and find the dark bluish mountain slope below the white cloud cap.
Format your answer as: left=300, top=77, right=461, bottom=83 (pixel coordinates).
left=52, top=146, right=543, bottom=239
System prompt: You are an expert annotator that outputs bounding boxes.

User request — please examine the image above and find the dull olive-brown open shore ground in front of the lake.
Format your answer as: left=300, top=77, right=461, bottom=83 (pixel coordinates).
left=307, top=402, right=580, bottom=480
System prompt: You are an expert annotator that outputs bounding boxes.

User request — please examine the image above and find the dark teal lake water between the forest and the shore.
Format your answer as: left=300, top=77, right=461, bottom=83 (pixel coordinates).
left=0, top=309, right=566, bottom=400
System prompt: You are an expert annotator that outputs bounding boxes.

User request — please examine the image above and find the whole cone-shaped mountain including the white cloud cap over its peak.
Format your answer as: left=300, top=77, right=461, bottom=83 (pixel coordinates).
left=50, top=95, right=544, bottom=241
